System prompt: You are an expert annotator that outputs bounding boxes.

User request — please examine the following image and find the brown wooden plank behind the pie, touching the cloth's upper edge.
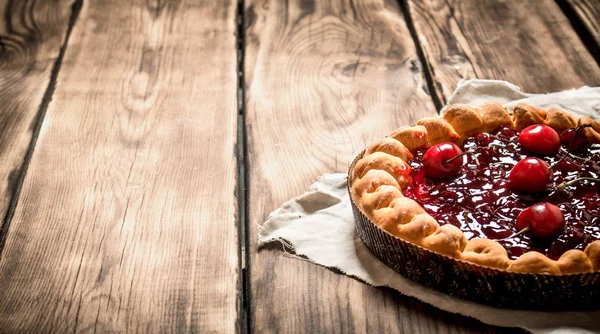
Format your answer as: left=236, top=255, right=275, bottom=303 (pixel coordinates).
left=408, top=0, right=600, bottom=102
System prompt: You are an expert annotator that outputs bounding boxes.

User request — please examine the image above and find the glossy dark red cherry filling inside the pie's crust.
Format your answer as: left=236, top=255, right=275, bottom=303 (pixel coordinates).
left=403, top=128, right=600, bottom=260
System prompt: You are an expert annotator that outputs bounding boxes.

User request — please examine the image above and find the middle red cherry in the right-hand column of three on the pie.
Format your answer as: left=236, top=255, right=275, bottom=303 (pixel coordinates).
left=509, top=158, right=552, bottom=193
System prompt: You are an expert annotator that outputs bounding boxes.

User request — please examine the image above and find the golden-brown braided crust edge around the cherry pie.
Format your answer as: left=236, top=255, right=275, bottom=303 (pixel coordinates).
left=349, top=103, right=600, bottom=275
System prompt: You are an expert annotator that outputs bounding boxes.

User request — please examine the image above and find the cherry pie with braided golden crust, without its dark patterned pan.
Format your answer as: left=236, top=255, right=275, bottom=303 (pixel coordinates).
left=349, top=103, right=600, bottom=275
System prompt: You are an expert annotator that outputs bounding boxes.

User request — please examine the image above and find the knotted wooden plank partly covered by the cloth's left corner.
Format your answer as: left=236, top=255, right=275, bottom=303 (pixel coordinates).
left=245, top=0, right=510, bottom=333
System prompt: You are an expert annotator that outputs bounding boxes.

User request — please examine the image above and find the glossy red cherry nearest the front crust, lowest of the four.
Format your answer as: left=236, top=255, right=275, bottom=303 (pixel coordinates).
left=516, top=202, right=565, bottom=239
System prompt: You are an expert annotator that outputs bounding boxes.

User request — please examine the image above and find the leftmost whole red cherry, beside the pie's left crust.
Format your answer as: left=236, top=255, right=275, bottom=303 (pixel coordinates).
left=423, top=143, right=463, bottom=179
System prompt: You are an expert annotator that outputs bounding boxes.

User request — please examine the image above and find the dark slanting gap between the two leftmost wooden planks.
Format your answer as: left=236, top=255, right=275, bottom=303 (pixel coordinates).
left=0, top=0, right=83, bottom=258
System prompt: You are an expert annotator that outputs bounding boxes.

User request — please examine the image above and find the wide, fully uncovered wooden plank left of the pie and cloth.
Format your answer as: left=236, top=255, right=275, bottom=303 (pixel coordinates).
left=0, top=0, right=238, bottom=333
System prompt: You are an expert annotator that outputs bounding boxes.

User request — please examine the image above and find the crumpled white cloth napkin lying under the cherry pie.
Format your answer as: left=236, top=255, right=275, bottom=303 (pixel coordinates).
left=258, top=80, right=600, bottom=333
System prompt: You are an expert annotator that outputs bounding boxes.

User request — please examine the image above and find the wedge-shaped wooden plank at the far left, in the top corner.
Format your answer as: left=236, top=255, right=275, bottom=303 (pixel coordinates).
left=0, top=0, right=74, bottom=232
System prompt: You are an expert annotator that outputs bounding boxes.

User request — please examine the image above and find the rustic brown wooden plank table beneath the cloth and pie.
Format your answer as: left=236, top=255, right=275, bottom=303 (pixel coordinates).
left=0, top=0, right=600, bottom=333
